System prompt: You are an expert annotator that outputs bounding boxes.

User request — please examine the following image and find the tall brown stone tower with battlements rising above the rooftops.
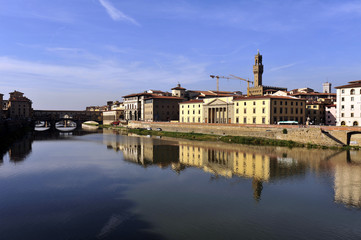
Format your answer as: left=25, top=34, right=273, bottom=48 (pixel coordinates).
left=249, top=51, right=287, bottom=96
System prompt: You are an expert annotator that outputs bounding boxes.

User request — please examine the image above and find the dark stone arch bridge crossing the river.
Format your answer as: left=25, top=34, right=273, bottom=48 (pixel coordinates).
left=32, top=110, right=103, bottom=129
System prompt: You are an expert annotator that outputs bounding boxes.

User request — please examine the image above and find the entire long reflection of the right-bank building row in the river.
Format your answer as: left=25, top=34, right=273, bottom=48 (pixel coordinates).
left=104, top=130, right=361, bottom=208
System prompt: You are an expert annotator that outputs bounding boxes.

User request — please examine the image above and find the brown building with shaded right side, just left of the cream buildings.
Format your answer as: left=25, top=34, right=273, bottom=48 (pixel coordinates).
left=144, top=96, right=184, bottom=122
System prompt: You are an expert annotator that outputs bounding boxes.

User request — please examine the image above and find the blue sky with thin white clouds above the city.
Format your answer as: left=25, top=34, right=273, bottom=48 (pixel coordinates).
left=0, top=0, right=361, bottom=109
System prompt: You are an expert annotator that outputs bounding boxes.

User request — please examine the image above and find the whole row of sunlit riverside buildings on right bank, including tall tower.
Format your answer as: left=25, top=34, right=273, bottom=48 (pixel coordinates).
left=98, top=52, right=361, bottom=126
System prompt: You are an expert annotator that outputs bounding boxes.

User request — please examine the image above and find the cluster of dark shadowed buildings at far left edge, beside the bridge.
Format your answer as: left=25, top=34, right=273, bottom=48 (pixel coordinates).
left=0, top=90, right=33, bottom=120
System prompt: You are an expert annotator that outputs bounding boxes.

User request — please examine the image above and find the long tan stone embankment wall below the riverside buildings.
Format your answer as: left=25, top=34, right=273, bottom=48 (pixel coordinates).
left=128, top=121, right=361, bottom=146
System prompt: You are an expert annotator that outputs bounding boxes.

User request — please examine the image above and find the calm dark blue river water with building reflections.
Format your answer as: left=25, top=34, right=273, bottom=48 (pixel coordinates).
left=0, top=130, right=361, bottom=240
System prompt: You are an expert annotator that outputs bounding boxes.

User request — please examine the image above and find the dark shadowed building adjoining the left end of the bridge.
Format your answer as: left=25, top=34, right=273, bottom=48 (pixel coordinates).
left=7, top=91, right=32, bottom=119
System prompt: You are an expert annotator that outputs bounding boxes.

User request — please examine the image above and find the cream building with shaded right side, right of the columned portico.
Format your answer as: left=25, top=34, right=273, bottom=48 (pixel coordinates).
left=233, top=96, right=306, bottom=124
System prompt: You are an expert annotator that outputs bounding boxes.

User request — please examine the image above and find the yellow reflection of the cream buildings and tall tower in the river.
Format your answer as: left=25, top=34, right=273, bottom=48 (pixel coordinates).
left=179, top=144, right=306, bottom=201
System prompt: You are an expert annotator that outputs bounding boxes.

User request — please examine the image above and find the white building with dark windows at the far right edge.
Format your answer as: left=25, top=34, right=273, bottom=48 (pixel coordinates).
left=335, top=80, right=361, bottom=126
